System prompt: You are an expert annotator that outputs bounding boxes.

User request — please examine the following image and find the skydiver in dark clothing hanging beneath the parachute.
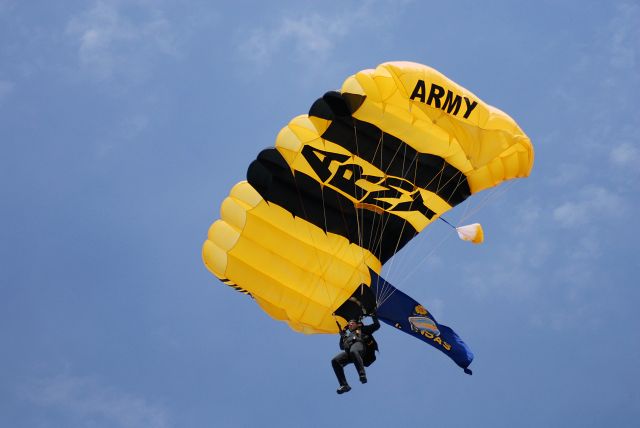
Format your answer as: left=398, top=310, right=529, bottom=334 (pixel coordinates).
left=331, top=314, right=380, bottom=394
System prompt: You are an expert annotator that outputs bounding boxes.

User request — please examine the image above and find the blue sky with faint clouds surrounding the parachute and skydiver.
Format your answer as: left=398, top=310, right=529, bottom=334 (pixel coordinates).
left=0, top=0, right=640, bottom=428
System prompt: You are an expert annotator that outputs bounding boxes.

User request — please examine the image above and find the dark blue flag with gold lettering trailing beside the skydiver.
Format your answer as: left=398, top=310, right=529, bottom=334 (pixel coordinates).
left=370, top=271, right=473, bottom=374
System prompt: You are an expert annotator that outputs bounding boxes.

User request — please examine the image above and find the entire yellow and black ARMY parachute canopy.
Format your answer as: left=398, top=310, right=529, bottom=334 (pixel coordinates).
left=202, top=62, right=534, bottom=333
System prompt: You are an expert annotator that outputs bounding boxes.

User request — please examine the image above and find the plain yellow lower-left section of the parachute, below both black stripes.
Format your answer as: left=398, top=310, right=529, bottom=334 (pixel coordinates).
left=203, top=182, right=381, bottom=333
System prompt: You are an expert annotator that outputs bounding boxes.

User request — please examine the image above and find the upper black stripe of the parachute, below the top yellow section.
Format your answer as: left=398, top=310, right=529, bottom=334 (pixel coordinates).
left=309, top=92, right=471, bottom=206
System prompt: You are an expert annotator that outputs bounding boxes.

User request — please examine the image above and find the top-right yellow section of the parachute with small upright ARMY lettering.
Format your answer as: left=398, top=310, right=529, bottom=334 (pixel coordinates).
left=342, top=62, right=534, bottom=191
